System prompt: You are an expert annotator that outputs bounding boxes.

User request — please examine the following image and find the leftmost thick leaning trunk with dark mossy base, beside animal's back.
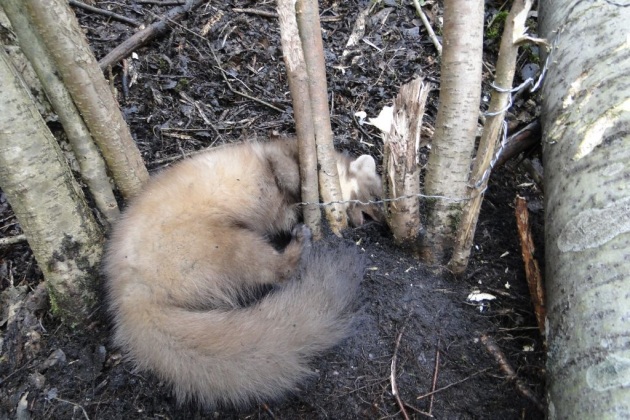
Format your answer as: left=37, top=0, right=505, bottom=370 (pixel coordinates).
left=0, top=48, right=103, bottom=323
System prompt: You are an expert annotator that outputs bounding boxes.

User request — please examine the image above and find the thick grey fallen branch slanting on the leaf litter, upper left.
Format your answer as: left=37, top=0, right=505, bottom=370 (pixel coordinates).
left=98, top=0, right=205, bottom=71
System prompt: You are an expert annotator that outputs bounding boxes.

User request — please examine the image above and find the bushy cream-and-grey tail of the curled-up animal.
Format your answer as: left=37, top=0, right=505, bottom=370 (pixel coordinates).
left=114, top=243, right=365, bottom=406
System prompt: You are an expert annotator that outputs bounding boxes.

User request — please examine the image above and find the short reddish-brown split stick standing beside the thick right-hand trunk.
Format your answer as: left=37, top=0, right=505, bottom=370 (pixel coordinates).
left=514, top=196, right=547, bottom=337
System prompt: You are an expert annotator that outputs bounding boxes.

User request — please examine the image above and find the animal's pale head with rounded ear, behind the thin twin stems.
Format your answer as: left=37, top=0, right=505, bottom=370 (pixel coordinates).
left=337, top=155, right=385, bottom=227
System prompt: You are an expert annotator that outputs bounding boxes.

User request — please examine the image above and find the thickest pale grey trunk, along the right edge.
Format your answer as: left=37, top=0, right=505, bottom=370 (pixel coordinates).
left=539, top=0, right=630, bottom=419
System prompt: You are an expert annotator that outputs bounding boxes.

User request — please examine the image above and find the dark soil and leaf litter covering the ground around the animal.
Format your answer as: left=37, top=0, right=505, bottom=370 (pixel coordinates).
left=0, top=0, right=545, bottom=419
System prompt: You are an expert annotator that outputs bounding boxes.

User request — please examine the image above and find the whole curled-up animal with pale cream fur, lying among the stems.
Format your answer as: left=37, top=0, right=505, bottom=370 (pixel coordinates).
left=103, top=139, right=380, bottom=406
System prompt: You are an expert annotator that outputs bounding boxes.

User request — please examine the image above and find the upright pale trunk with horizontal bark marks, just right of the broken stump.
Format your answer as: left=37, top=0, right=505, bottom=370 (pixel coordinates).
left=420, top=0, right=483, bottom=263
